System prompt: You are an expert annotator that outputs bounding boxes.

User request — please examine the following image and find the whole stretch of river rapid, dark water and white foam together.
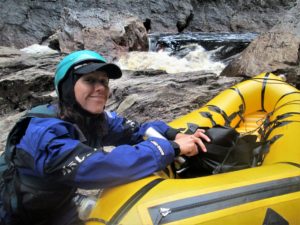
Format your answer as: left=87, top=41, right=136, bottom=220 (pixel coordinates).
left=118, top=33, right=257, bottom=75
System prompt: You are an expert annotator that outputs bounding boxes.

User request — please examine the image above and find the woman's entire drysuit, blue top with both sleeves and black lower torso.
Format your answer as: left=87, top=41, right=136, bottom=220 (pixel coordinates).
left=0, top=106, right=175, bottom=224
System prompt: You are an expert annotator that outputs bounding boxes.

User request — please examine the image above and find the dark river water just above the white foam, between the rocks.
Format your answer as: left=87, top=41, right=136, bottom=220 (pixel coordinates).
left=149, top=32, right=258, bottom=61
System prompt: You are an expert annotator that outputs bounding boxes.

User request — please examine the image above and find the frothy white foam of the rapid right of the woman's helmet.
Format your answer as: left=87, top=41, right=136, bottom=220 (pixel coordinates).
left=118, top=45, right=225, bottom=74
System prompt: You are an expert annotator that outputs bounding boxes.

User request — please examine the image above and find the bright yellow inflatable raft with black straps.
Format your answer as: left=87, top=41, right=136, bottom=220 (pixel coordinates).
left=86, top=73, right=300, bottom=225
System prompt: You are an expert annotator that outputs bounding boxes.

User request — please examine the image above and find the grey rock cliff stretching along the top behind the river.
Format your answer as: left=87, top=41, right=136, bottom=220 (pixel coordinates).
left=0, top=0, right=296, bottom=48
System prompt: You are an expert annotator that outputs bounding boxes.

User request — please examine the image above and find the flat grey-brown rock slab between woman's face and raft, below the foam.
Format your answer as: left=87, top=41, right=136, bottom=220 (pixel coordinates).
left=108, top=71, right=239, bottom=122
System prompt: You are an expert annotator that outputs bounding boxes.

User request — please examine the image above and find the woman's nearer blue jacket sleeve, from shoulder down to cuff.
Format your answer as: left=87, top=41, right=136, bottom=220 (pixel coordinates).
left=18, top=118, right=174, bottom=189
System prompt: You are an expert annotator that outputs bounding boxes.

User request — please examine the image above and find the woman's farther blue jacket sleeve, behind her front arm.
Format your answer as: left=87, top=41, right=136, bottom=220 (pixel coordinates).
left=103, top=112, right=179, bottom=145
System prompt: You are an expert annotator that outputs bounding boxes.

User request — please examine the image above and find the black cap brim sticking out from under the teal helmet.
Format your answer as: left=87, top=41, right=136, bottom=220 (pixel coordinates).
left=75, top=63, right=122, bottom=79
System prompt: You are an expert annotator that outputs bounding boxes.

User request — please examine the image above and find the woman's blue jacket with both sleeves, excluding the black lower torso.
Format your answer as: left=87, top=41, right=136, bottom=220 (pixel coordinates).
left=17, top=106, right=175, bottom=189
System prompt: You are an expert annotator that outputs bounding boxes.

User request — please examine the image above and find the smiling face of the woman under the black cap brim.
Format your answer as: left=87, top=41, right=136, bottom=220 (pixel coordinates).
left=74, top=71, right=109, bottom=114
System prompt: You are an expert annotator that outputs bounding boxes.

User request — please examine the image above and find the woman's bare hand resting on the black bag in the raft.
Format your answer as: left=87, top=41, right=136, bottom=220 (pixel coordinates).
left=174, top=129, right=210, bottom=156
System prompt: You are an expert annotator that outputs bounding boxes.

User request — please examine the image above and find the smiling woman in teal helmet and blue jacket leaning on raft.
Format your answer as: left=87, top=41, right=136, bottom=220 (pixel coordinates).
left=0, top=50, right=209, bottom=225
